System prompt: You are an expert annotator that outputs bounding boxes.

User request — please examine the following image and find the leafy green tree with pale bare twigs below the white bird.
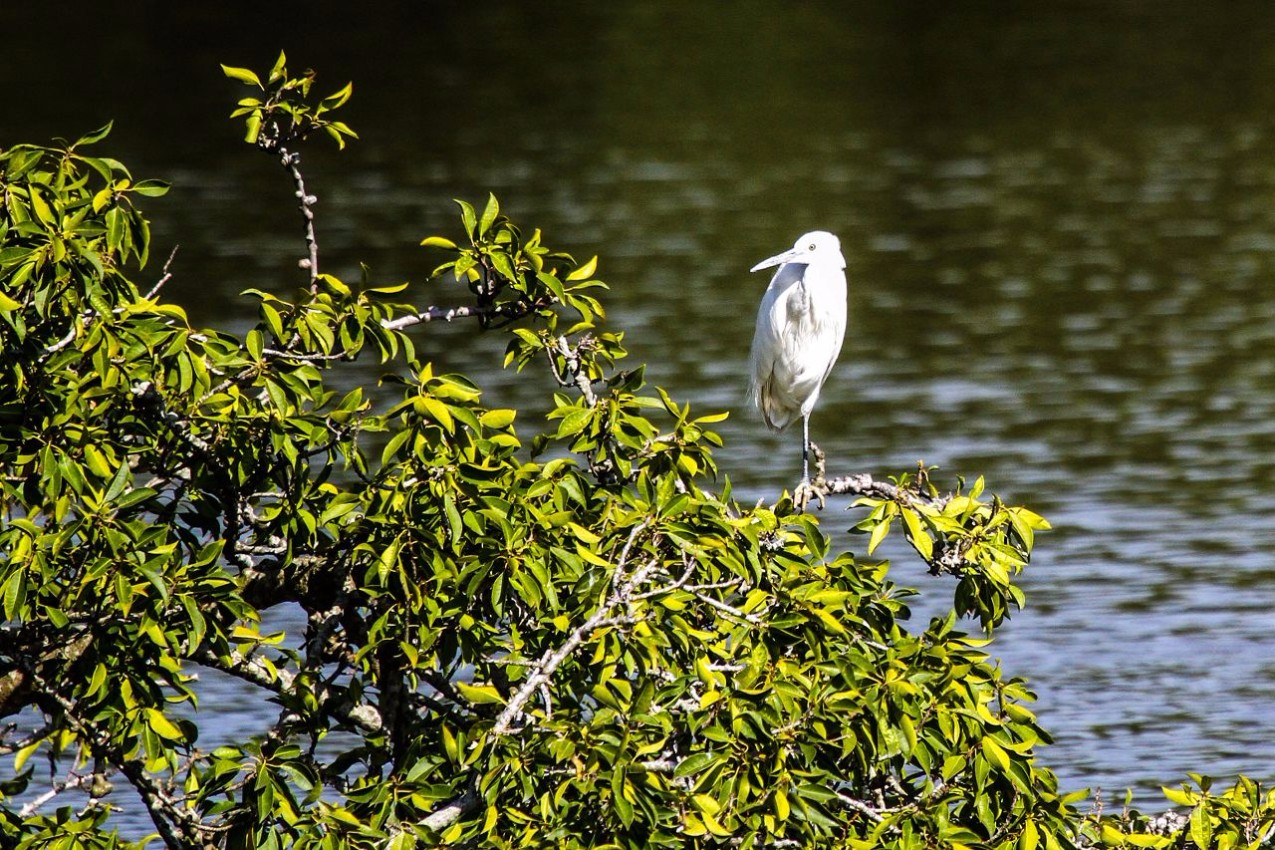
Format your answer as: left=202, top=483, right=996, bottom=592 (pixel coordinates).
left=0, top=55, right=1275, bottom=849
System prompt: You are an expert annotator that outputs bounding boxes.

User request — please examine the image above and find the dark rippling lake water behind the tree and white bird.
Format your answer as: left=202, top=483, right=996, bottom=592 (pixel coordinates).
left=9, top=0, right=1275, bottom=835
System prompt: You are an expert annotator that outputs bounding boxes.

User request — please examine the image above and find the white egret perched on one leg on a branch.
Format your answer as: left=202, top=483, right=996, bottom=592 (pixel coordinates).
left=748, top=231, right=845, bottom=488
